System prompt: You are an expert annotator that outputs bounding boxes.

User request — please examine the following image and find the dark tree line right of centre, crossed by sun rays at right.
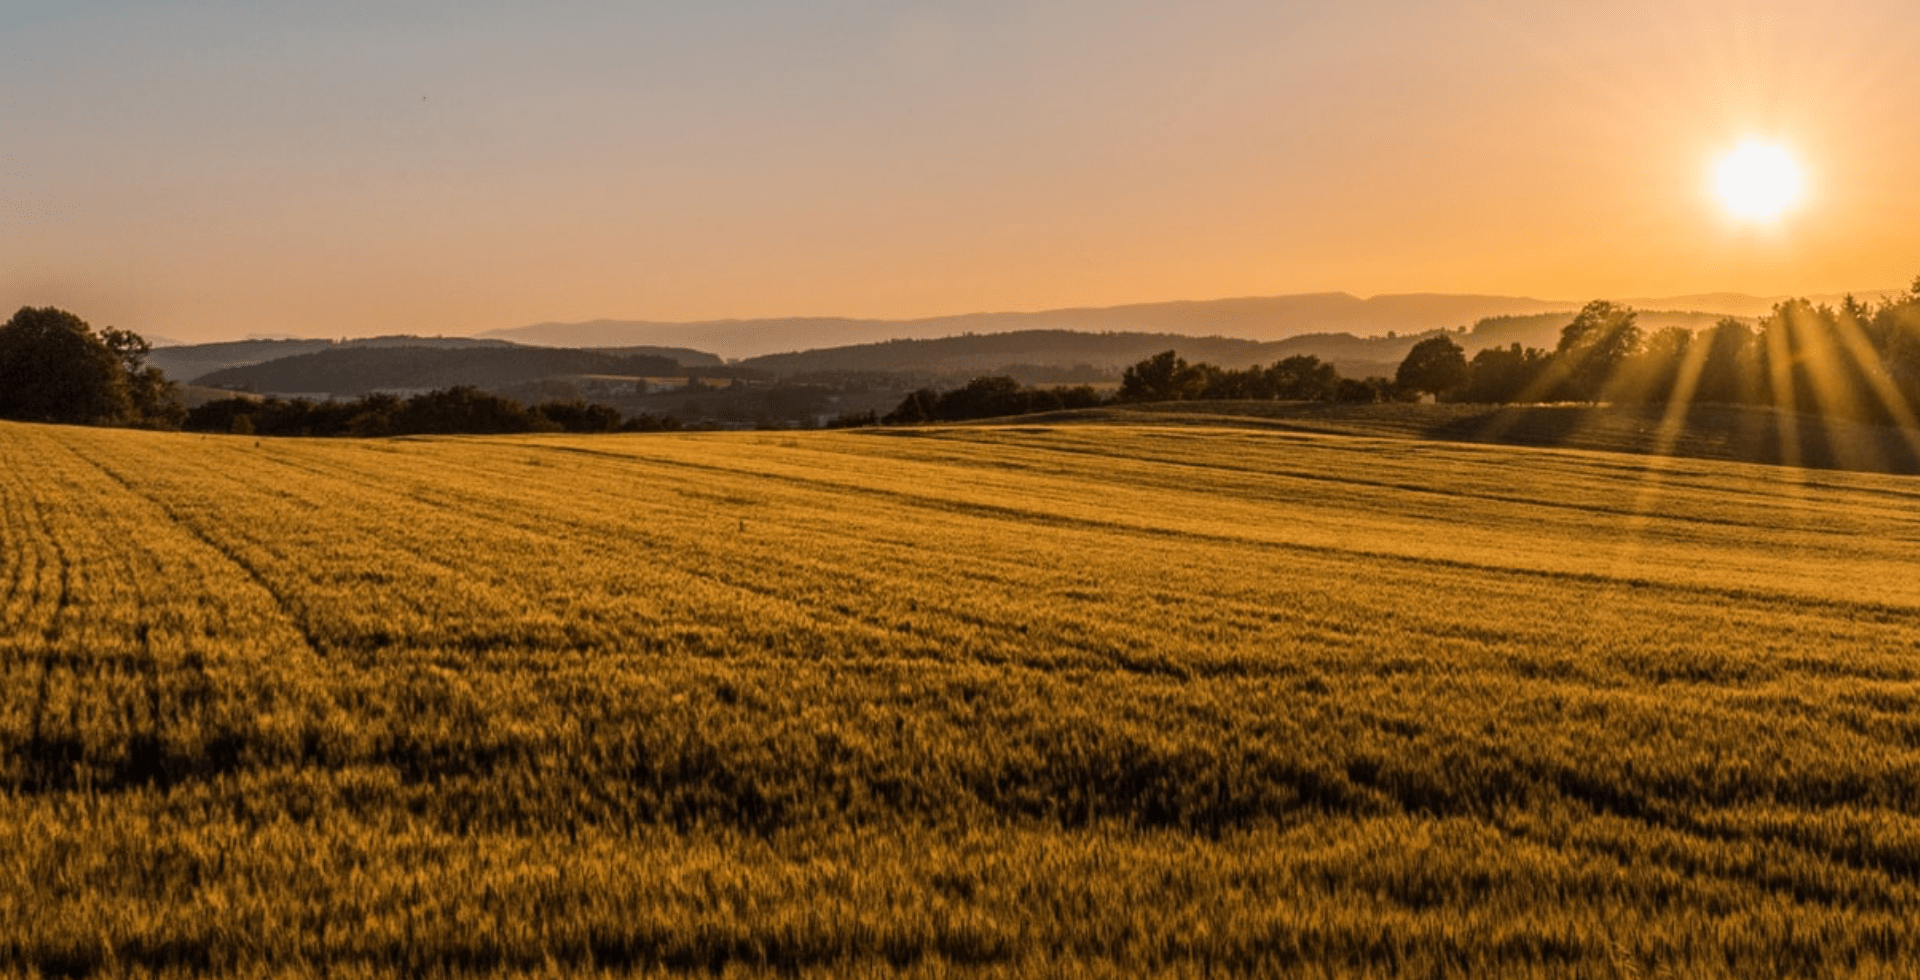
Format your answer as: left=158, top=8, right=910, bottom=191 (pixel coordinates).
left=871, top=279, right=1920, bottom=425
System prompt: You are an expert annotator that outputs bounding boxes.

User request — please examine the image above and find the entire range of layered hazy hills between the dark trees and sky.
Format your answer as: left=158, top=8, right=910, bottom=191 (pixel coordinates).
left=150, top=286, right=1896, bottom=405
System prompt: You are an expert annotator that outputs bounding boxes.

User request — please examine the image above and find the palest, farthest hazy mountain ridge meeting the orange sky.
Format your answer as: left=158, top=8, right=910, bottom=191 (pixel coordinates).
left=480, top=290, right=1899, bottom=359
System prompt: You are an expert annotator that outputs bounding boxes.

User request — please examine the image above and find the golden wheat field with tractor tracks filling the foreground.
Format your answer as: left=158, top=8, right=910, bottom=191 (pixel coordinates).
left=0, top=416, right=1920, bottom=978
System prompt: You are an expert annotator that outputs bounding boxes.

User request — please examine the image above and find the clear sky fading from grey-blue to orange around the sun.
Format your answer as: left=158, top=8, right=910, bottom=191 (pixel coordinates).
left=0, top=0, right=1920, bottom=340
